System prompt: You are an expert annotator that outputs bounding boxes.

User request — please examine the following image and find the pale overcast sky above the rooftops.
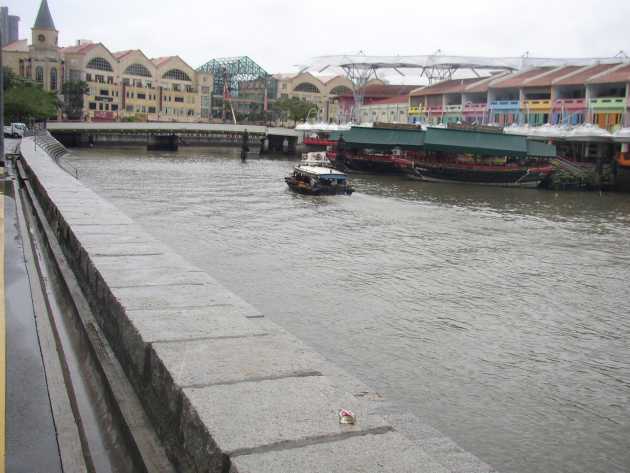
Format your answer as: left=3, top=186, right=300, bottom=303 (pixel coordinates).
left=3, top=0, right=630, bottom=76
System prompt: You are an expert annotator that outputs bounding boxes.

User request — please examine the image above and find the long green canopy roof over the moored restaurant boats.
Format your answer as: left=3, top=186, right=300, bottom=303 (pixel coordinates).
left=331, top=127, right=556, bottom=157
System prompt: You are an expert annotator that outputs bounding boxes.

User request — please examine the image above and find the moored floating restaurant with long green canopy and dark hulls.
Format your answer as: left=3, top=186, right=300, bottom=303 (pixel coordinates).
left=336, top=125, right=556, bottom=187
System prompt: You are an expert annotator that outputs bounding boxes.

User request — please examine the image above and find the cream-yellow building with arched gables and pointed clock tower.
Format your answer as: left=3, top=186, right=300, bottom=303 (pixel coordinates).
left=3, top=0, right=213, bottom=122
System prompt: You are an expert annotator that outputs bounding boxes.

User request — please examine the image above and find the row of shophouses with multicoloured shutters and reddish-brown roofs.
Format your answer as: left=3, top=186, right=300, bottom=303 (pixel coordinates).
left=409, top=61, right=630, bottom=131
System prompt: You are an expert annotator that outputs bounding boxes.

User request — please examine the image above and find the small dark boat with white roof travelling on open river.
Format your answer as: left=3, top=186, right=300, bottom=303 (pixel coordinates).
left=284, top=153, right=354, bottom=195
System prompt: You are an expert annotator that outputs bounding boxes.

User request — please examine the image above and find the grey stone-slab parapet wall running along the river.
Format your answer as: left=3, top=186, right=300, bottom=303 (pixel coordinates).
left=22, top=134, right=493, bottom=473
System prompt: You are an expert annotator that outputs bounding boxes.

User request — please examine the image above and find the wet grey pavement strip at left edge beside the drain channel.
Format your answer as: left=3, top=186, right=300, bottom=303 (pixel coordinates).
left=0, top=168, right=61, bottom=473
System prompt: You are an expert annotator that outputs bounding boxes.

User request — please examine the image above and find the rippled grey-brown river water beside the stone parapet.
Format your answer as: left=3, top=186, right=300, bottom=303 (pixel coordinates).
left=68, top=149, right=630, bottom=473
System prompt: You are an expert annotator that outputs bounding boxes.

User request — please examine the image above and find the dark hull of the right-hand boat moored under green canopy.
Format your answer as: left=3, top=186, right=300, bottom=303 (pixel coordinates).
left=408, top=164, right=550, bottom=188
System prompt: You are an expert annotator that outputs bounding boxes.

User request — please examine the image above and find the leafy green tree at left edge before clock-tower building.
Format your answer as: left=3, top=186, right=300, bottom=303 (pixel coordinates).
left=3, top=70, right=59, bottom=123
